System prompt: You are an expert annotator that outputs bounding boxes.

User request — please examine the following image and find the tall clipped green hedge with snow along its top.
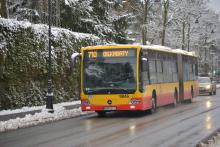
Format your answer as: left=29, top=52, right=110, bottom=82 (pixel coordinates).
left=0, top=18, right=101, bottom=109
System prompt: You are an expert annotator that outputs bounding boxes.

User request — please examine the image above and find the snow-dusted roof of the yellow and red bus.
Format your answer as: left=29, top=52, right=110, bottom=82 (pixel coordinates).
left=83, top=44, right=197, bottom=57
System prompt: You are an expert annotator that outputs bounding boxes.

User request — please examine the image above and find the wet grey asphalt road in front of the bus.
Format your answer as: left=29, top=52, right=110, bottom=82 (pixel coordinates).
left=0, top=90, right=220, bottom=147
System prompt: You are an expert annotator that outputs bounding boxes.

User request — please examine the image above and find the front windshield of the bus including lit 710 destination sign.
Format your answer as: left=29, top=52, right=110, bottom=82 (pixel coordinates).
left=84, top=49, right=136, bottom=94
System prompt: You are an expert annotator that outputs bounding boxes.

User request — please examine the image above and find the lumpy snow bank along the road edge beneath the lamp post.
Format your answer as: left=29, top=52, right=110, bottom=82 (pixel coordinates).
left=0, top=105, right=93, bottom=132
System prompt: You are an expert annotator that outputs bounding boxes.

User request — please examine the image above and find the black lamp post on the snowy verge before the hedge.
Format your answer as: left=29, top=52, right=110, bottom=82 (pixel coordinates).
left=46, top=0, right=54, bottom=113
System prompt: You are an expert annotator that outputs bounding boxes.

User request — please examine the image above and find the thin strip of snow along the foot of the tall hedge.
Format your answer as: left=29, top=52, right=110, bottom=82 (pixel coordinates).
left=0, top=101, right=81, bottom=116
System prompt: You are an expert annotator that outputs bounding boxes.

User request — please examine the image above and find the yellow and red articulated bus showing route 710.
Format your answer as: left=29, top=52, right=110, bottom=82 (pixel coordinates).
left=72, top=45, right=198, bottom=116
